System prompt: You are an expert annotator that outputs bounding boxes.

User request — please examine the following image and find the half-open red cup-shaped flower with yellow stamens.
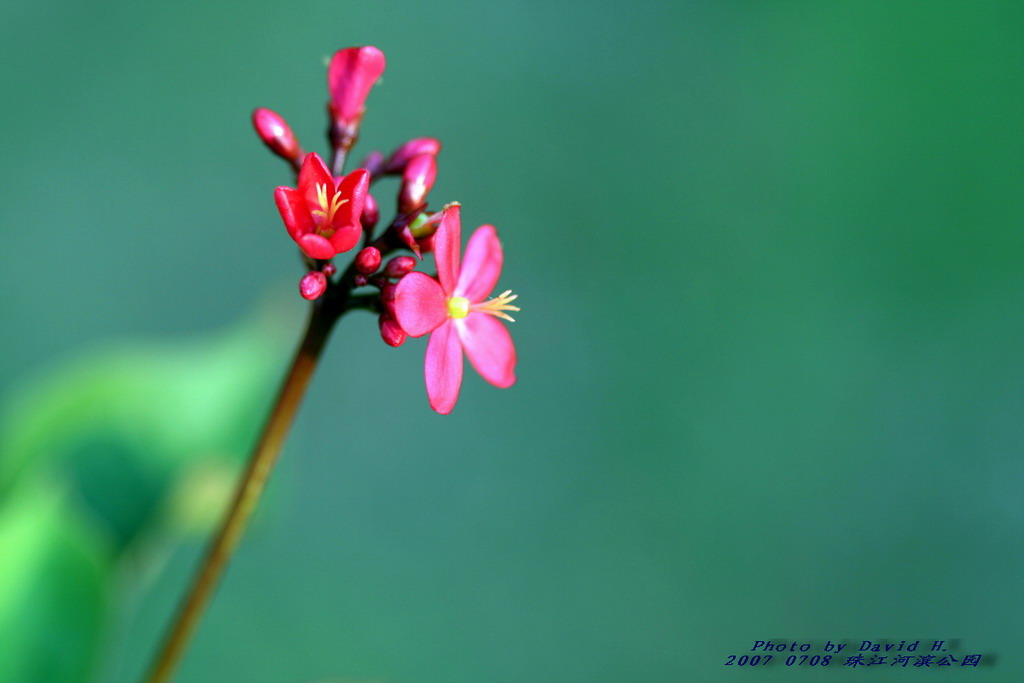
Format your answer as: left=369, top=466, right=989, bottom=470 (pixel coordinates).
left=273, top=153, right=370, bottom=259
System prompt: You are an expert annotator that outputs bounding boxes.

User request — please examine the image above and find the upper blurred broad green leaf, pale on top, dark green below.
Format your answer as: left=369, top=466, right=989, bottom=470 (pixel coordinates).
left=0, top=317, right=284, bottom=549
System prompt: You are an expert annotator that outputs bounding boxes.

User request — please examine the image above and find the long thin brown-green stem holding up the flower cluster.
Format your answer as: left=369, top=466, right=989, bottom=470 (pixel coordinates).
left=146, top=304, right=339, bottom=683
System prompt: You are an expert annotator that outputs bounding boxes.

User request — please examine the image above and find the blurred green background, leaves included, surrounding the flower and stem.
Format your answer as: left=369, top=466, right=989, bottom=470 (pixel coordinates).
left=0, top=0, right=1024, bottom=683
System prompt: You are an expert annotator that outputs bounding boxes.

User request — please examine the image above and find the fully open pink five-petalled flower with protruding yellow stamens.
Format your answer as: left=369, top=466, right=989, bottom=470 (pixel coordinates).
left=394, top=204, right=519, bottom=415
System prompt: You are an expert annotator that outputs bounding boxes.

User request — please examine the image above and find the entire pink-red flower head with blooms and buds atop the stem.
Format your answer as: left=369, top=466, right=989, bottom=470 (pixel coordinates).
left=252, top=46, right=518, bottom=413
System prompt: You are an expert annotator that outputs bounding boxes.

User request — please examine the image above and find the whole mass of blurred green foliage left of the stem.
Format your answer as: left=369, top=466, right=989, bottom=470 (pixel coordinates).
left=0, top=313, right=290, bottom=683
